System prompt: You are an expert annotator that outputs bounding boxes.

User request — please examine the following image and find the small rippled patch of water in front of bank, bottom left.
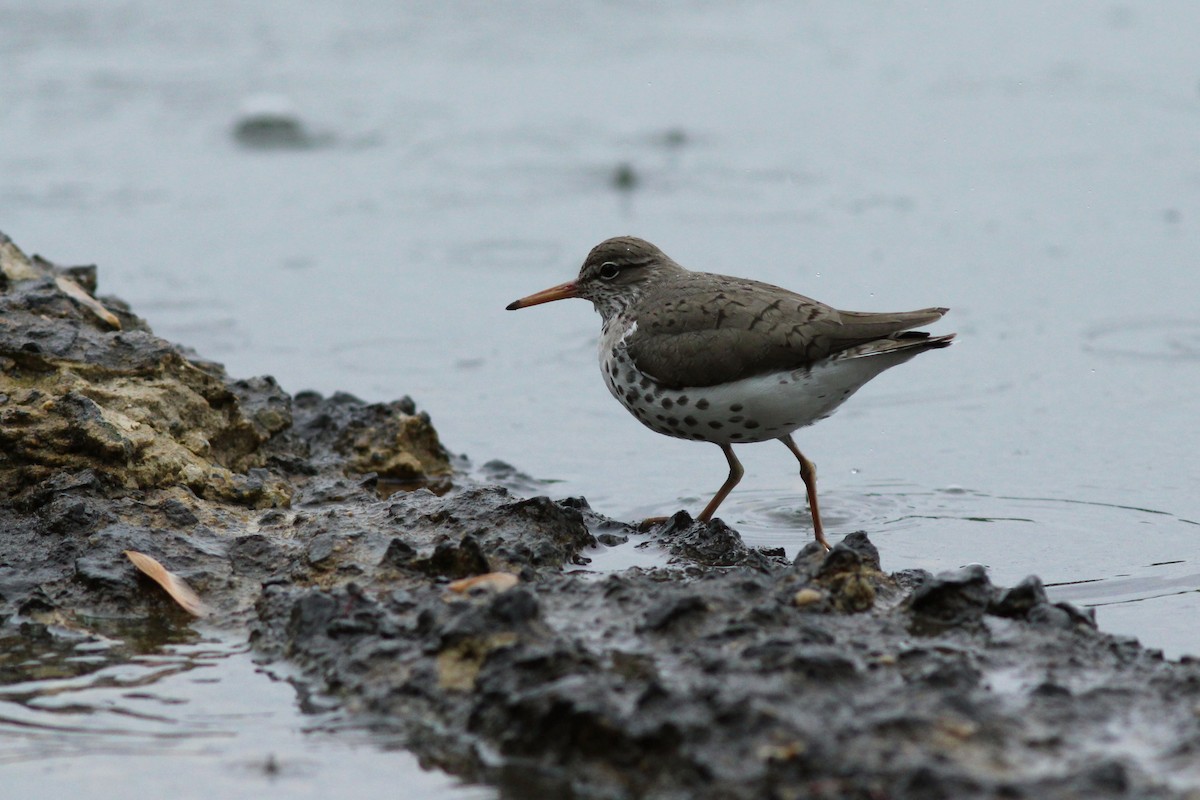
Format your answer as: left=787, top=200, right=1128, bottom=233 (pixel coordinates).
left=0, top=618, right=496, bottom=800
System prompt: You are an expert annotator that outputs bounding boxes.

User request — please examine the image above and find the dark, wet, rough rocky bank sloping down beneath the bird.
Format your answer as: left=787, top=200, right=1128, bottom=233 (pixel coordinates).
left=0, top=232, right=1200, bottom=799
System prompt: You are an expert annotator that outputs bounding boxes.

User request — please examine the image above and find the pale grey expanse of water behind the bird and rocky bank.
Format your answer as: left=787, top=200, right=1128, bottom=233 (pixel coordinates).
left=0, top=0, right=1200, bottom=784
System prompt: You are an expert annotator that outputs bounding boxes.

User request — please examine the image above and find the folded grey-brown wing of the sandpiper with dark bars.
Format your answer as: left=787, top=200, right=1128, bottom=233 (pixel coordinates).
left=625, top=272, right=946, bottom=386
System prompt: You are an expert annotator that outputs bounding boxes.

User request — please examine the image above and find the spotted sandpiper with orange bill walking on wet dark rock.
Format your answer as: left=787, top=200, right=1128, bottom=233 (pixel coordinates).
left=508, top=236, right=954, bottom=549
